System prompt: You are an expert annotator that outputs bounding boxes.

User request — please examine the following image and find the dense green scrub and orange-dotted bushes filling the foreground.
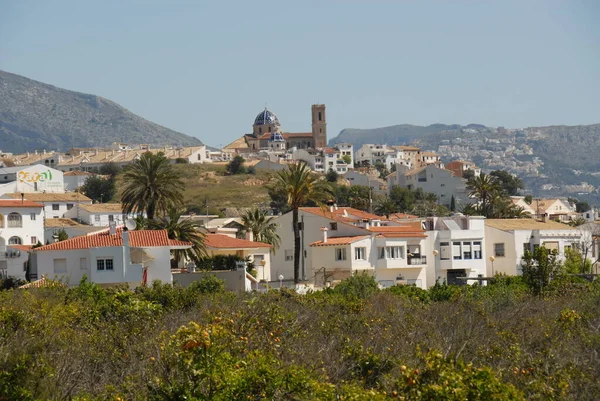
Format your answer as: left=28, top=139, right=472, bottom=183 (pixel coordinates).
left=0, top=276, right=600, bottom=400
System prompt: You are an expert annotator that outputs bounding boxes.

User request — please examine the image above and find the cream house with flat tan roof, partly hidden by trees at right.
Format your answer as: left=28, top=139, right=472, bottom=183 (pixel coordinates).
left=485, top=219, right=592, bottom=276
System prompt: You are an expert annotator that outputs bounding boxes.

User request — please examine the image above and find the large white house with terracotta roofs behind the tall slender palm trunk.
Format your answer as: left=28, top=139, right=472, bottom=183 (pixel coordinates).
left=271, top=207, right=428, bottom=288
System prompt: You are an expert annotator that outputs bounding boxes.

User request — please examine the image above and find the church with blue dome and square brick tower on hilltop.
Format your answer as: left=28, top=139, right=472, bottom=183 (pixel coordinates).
left=225, top=104, right=327, bottom=153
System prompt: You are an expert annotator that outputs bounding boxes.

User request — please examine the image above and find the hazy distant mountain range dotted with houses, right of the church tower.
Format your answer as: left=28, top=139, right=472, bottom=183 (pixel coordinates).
left=330, top=124, right=600, bottom=203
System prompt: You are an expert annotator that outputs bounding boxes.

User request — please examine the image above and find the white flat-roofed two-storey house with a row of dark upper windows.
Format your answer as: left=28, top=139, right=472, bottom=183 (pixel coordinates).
left=423, top=213, right=491, bottom=285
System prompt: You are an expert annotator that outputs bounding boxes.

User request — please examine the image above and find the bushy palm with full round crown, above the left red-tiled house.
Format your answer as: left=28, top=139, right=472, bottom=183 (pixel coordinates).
left=121, top=152, right=183, bottom=220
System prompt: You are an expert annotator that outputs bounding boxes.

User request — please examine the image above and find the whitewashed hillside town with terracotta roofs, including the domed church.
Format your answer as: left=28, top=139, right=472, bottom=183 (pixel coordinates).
left=0, top=104, right=600, bottom=291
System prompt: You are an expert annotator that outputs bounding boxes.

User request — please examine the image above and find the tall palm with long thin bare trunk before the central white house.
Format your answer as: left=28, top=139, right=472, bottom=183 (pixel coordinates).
left=274, top=162, right=333, bottom=283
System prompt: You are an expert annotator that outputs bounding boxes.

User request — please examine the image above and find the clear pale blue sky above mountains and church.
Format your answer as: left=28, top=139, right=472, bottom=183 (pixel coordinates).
left=0, top=0, right=600, bottom=146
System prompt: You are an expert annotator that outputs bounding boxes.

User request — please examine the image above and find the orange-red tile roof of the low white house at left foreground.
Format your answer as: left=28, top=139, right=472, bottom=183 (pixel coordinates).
left=33, top=229, right=192, bottom=252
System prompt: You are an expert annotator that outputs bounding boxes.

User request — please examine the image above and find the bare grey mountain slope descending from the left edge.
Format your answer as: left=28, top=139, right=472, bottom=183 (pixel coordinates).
left=0, top=71, right=202, bottom=153
